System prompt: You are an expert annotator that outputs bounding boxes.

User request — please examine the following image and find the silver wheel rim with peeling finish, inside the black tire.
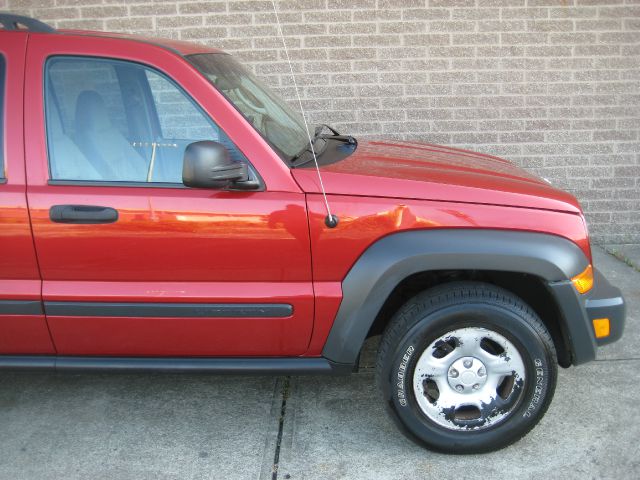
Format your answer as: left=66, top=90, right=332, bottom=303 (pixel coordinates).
left=413, top=327, right=525, bottom=430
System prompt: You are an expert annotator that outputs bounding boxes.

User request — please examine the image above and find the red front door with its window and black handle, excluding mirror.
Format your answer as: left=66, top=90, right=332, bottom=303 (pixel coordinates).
left=25, top=35, right=313, bottom=356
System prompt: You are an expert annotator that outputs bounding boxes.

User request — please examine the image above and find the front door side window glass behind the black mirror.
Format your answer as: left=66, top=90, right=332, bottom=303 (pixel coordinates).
left=45, top=57, right=247, bottom=183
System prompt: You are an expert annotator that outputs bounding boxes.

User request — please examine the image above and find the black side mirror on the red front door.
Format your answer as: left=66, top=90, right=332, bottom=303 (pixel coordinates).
left=182, top=140, right=249, bottom=188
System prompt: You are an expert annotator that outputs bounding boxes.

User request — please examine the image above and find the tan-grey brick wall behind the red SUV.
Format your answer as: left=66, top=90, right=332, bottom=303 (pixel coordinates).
left=5, top=0, right=640, bottom=243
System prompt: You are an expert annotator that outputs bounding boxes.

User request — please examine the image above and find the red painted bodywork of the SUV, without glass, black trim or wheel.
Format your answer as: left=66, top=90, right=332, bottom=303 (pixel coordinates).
left=0, top=27, right=616, bottom=364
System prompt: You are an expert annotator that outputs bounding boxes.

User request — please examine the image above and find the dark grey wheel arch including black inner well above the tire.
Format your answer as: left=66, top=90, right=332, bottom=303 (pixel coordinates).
left=323, top=229, right=595, bottom=366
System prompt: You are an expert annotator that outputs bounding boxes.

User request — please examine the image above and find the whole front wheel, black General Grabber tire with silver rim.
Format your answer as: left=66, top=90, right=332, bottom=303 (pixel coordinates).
left=376, top=282, right=558, bottom=454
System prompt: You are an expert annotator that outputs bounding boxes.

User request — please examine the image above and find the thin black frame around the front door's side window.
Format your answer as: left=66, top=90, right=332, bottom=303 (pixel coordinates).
left=43, top=54, right=266, bottom=192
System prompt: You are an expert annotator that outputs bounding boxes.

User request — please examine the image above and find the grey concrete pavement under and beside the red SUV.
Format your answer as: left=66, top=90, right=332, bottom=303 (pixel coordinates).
left=0, top=249, right=640, bottom=480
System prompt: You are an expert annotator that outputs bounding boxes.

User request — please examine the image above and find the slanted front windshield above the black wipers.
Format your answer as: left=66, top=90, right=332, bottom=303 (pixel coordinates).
left=187, top=53, right=309, bottom=160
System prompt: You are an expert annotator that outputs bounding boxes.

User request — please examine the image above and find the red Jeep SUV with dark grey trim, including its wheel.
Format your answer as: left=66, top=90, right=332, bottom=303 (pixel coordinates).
left=0, top=14, right=625, bottom=453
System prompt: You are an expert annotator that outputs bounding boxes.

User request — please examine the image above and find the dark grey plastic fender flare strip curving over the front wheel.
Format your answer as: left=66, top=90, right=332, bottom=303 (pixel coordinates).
left=322, top=229, right=596, bottom=364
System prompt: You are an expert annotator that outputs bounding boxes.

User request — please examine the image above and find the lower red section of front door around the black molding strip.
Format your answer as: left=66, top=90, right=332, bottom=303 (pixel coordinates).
left=43, top=281, right=313, bottom=356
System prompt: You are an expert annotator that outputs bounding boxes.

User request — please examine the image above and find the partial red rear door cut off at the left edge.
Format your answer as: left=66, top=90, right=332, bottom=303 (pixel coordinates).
left=0, top=32, right=54, bottom=355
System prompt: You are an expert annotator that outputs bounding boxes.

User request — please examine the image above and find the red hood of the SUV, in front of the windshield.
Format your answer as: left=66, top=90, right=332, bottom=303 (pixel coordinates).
left=292, top=141, right=581, bottom=213
